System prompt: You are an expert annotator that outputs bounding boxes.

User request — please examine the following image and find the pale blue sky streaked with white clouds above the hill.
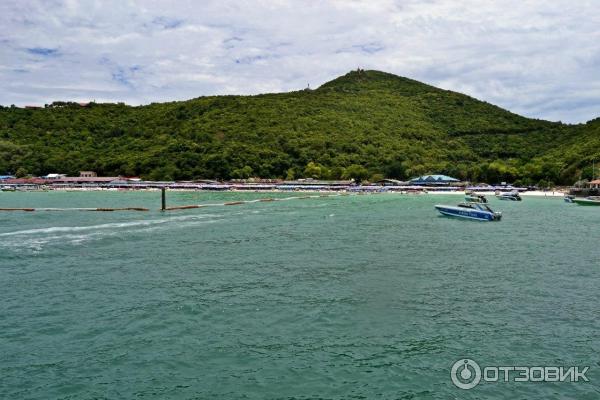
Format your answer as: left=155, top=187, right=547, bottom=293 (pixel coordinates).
left=0, top=0, right=600, bottom=123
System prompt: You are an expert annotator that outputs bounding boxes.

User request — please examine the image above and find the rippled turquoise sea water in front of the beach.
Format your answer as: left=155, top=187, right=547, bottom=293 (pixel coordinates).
left=0, top=192, right=600, bottom=399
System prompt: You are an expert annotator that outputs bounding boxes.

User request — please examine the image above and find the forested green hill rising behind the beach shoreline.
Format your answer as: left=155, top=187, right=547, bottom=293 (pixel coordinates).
left=0, top=70, right=600, bottom=184
